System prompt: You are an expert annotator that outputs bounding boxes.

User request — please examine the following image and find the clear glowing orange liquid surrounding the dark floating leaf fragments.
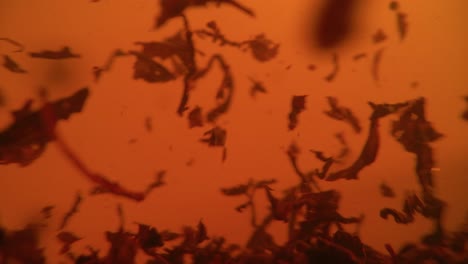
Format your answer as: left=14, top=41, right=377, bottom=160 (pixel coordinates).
left=0, top=0, right=468, bottom=263
